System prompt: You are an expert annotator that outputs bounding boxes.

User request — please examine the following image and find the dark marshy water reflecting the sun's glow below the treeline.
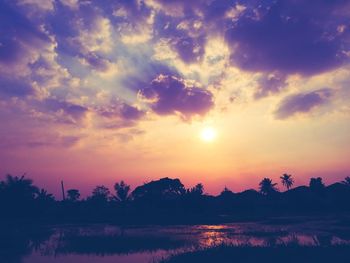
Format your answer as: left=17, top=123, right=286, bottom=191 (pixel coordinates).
left=0, top=218, right=350, bottom=263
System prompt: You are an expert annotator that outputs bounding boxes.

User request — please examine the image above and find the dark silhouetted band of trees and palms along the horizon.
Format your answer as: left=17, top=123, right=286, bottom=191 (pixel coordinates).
left=0, top=174, right=350, bottom=224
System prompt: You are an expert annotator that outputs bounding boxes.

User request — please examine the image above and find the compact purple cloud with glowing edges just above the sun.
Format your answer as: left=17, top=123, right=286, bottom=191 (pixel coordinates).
left=140, top=75, right=213, bottom=117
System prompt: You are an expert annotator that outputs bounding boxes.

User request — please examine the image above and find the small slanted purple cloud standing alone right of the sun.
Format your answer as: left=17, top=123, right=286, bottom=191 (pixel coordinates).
left=275, top=88, right=332, bottom=119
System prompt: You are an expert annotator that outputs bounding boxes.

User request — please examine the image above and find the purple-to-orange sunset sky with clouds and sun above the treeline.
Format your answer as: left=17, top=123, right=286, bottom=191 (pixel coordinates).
left=0, top=0, right=350, bottom=196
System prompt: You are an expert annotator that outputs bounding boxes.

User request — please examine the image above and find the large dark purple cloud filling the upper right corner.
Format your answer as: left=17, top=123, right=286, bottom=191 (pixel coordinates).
left=225, top=0, right=348, bottom=75
